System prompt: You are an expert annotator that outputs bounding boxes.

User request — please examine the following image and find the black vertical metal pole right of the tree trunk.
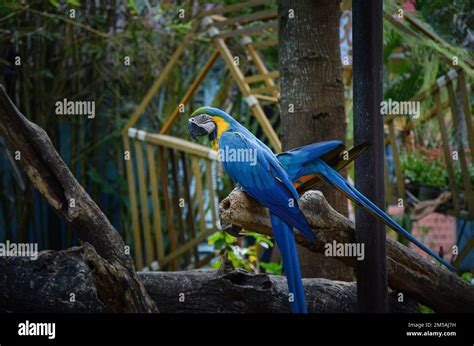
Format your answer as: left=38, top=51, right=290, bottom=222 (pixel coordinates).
left=352, top=0, right=388, bottom=312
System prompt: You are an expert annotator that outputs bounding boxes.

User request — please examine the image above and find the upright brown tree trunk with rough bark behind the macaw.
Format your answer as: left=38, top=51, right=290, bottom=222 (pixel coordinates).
left=278, top=0, right=352, bottom=280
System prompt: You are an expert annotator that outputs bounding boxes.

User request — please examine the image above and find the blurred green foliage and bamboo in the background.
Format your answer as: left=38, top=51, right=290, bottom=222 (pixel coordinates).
left=0, top=0, right=474, bottom=272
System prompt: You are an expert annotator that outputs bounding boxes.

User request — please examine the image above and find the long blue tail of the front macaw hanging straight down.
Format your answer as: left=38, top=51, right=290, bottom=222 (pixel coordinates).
left=270, top=213, right=308, bottom=313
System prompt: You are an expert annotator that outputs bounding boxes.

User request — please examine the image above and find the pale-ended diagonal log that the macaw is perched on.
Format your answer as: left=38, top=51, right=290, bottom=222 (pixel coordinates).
left=219, top=190, right=474, bottom=312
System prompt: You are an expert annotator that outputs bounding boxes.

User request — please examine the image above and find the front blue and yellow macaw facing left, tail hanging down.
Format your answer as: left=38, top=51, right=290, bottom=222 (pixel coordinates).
left=189, top=107, right=314, bottom=313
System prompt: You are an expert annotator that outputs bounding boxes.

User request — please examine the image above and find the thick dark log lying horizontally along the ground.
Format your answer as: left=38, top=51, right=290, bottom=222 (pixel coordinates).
left=0, top=247, right=418, bottom=313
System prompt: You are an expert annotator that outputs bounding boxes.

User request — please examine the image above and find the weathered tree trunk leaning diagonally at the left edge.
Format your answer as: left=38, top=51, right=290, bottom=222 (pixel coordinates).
left=0, top=85, right=157, bottom=312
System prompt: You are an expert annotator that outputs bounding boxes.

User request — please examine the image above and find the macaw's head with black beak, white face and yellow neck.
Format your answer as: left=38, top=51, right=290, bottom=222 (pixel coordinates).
left=188, top=107, right=235, bottom=141
